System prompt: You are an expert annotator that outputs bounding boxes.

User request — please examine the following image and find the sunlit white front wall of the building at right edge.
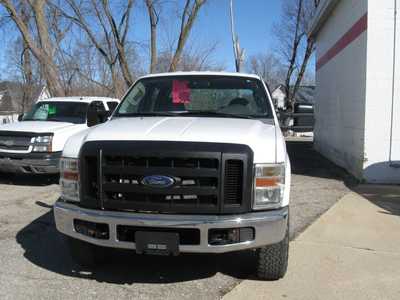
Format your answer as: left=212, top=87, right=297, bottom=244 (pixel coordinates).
left=363, top=0, right=400, bottom=183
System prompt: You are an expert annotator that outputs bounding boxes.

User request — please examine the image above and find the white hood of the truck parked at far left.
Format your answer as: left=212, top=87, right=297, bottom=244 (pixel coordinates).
left=0, top=121, right=75, bottom=133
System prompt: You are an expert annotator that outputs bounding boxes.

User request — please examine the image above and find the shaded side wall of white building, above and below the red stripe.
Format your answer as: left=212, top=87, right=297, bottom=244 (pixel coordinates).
left=314, top=0, right=368, bottom=177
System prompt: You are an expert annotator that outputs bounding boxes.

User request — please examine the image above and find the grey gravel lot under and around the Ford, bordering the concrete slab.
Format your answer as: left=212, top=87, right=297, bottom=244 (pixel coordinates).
left=0, top=142, right=348, bottom=299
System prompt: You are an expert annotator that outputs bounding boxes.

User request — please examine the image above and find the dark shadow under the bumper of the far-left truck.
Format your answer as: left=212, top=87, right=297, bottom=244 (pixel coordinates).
left=0, top=172, right=60, bottom=186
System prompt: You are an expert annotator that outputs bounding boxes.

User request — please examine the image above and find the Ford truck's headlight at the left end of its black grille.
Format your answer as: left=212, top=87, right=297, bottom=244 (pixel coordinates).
left=60, top=157, right=79, bottom=202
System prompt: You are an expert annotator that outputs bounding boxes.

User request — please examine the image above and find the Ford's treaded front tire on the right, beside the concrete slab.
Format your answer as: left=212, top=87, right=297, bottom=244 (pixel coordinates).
left=257, top=226, right=289, bottom=280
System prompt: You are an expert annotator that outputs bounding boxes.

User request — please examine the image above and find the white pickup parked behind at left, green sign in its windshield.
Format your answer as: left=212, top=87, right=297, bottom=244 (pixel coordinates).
left=0, top=97, right=119, bottom=174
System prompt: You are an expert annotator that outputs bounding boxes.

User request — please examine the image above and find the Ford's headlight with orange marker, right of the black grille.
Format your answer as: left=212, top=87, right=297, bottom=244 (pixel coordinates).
left=253, top=164, right=285, bottom=210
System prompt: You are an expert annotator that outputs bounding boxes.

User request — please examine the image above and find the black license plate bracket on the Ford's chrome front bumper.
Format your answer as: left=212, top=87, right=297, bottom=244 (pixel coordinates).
left=135, top=231, right=179, bottom=255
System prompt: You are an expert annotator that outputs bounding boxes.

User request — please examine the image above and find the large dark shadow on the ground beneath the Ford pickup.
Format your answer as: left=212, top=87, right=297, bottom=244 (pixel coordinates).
left=16, top=211, right=256, bottom=284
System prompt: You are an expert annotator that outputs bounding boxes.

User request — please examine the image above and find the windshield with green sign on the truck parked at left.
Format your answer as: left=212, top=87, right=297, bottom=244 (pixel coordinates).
left=22, top=101, right=88, bottom=124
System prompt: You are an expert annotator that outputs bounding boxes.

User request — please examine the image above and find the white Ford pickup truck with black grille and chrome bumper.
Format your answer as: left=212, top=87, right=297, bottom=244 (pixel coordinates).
left=54, top=72, right=291, bottom=280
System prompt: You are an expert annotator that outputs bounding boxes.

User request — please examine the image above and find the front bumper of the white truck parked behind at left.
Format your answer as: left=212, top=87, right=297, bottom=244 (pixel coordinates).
left=0, top=152, right=61, bottom=174
